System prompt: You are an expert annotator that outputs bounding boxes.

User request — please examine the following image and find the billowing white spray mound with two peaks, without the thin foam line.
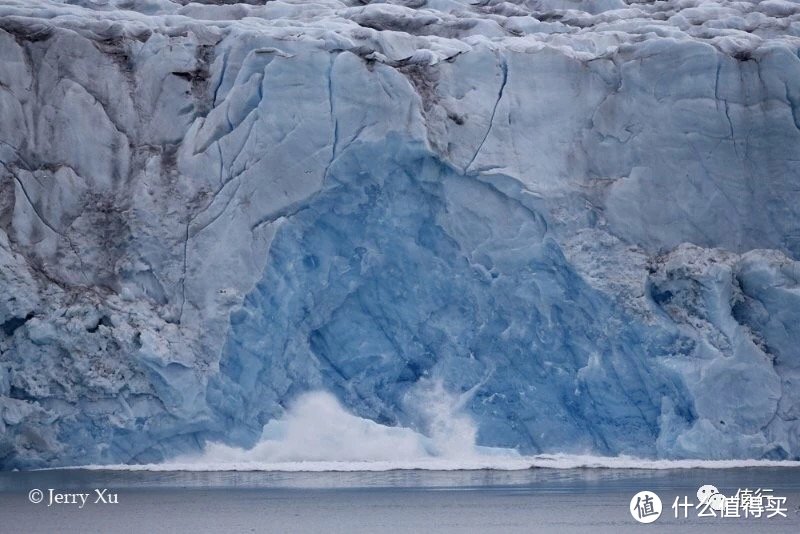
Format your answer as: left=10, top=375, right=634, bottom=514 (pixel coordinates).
left=167, top=380, right=520, bottom=470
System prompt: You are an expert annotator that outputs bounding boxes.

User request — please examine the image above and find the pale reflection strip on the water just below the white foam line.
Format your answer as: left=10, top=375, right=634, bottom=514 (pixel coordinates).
left=0, top=467, right=800, bottom=493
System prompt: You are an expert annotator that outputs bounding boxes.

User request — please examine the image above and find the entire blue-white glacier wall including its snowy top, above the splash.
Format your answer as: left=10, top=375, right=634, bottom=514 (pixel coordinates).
left=0, top=0, right=800, bottom=468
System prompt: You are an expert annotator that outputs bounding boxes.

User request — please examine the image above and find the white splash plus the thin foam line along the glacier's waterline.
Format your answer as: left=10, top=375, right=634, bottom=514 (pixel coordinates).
left=79, top=392, right=800, bottom=472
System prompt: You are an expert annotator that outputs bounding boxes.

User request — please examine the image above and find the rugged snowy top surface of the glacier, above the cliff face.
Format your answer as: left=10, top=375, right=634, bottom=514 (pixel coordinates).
left=0, top=0, right=800, bottom=64
